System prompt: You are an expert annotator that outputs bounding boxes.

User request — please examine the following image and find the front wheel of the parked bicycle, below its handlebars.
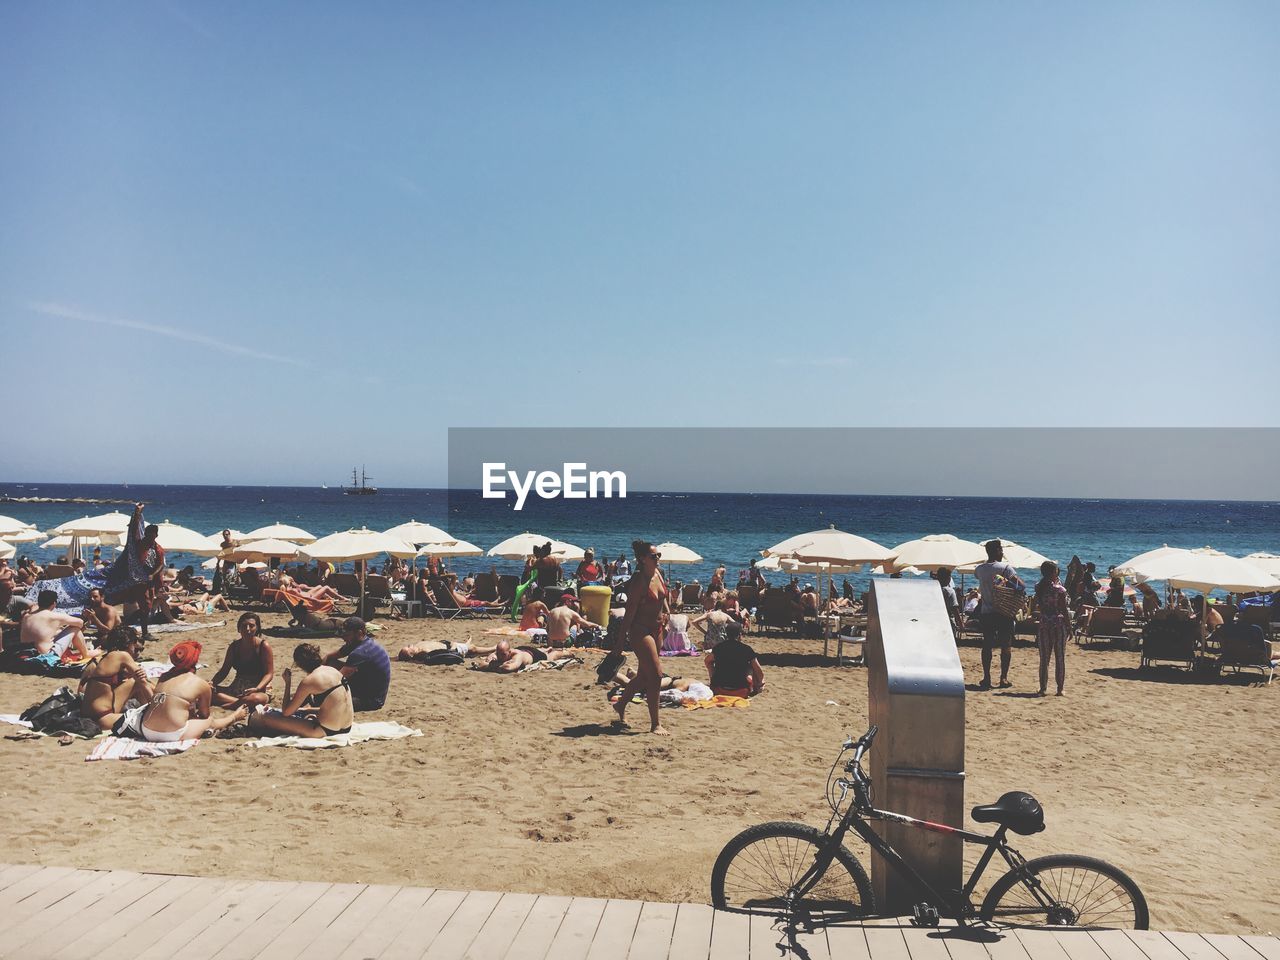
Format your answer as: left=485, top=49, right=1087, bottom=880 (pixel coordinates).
left=712, top=820, right=876, bottom=916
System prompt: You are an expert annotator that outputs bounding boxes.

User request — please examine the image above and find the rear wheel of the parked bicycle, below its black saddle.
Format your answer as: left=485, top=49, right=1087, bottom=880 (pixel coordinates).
left=982, top=855, right=1151, bottom=931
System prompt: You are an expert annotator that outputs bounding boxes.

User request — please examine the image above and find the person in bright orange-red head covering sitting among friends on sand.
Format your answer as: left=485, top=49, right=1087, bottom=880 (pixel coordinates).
left=111, top=640, right=248, bottom=744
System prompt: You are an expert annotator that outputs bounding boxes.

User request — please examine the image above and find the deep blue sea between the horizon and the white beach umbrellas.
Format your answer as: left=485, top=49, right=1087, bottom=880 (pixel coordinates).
left=0, top=483, right=1280, bottom=599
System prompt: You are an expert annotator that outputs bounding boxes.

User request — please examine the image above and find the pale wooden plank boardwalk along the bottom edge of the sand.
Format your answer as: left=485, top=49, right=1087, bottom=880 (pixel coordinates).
left=0, top=865, right=1280, bottom=960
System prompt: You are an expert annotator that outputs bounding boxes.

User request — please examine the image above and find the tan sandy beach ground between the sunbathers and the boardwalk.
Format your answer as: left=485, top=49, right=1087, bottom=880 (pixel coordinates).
left=0, top=614, right=1280, bottom=933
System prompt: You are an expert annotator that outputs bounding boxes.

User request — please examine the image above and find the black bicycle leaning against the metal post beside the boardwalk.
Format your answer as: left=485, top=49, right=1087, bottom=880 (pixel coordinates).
left=712, top=726, right=1149, bottom=931
